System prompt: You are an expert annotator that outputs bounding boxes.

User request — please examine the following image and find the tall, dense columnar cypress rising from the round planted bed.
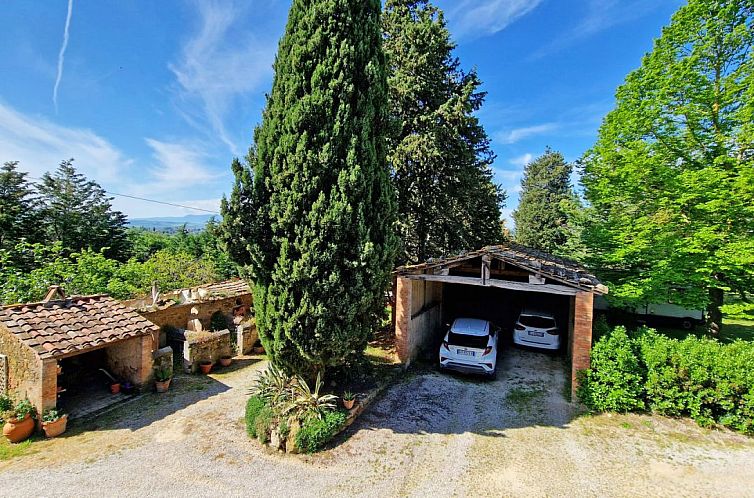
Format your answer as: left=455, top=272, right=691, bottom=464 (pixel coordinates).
left=248, top=0, right=397, bottom=377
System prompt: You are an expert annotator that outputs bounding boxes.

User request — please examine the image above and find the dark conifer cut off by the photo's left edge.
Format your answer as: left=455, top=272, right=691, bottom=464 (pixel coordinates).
left=0, top=161, right=39, bottom=249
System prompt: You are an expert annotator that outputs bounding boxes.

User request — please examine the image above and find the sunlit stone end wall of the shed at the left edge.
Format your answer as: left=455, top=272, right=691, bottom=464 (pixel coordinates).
left=0, top=325, right=42, bottom=408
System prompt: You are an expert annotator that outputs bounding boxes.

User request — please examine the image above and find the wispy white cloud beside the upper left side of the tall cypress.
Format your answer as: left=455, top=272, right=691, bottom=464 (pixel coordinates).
left=168, top=1, right=276, bottom=154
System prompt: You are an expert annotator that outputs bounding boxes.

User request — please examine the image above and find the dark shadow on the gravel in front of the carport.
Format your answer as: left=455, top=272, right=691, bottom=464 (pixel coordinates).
left=347, top=348, right=582, bottom=438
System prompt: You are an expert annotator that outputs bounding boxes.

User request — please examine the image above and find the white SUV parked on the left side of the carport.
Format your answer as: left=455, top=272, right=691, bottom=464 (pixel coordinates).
left=440, top=318, right=499, bottom=378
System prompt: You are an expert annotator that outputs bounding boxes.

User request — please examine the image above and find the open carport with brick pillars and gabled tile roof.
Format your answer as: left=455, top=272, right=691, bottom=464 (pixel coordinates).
left=393, top=243, right=608, bottom=391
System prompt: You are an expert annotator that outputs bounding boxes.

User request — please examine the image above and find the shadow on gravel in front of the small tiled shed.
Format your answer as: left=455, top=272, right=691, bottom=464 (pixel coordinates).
left=60, top=357, right=265, bottom=438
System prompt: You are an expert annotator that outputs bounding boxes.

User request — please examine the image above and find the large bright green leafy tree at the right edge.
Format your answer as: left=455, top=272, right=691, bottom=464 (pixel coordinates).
left=583, top=0, right=754, bottom=334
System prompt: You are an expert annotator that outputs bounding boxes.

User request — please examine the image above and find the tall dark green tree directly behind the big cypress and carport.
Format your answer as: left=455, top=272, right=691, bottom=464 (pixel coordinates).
left=383, top=0, right=505, bottom=262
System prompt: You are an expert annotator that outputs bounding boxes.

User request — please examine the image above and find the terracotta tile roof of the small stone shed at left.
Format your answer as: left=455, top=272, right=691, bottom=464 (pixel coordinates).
left=0, top=295, right=159, bottom=358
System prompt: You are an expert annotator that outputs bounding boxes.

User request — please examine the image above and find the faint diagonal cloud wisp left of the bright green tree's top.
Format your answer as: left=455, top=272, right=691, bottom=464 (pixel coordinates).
left=531, top=0, right=662, bottom=59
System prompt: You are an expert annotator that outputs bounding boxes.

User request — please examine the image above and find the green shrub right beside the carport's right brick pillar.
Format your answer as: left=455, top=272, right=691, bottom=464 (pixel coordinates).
left=578, top=327, right=645, bottom=412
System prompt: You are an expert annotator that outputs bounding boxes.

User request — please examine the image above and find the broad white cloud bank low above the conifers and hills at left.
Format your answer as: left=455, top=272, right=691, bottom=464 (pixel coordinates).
left=0, top=102, right=225, bottom=217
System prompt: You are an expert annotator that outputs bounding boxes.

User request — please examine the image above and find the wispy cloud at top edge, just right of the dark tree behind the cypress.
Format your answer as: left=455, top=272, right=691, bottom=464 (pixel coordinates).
left=448, top=0, right=543, bottom=39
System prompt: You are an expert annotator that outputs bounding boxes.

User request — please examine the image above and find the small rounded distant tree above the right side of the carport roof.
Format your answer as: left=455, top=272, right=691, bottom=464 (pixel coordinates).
left=513, top=148, right=574, bottom=254
